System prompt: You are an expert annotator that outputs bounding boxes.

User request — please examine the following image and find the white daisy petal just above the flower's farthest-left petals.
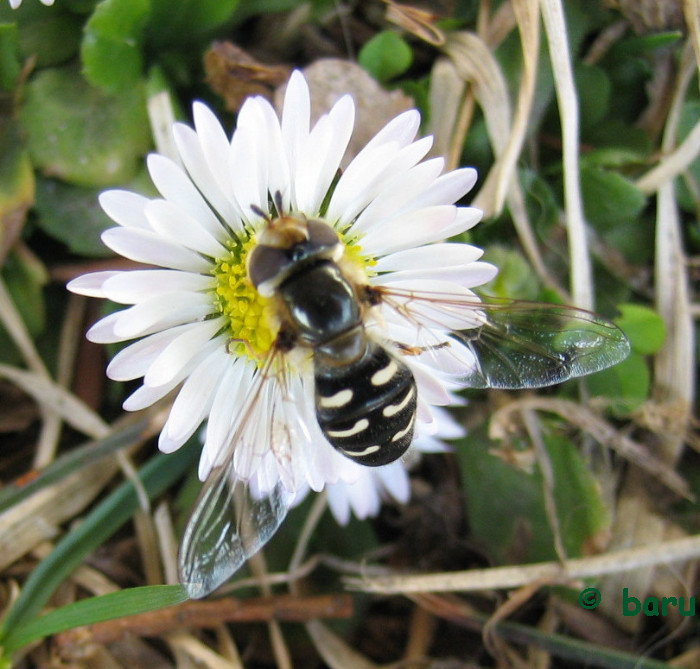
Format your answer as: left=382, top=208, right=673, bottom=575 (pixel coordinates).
left=102, top=228, right=211, bottom=273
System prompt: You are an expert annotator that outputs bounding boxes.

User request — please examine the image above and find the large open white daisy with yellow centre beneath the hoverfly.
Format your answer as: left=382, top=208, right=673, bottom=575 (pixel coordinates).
left=69, top=72, right=496, bottom=520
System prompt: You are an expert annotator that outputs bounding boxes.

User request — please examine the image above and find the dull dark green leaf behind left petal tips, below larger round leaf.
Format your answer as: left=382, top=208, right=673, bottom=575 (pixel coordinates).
left=35, top=179, right=114, bottom=257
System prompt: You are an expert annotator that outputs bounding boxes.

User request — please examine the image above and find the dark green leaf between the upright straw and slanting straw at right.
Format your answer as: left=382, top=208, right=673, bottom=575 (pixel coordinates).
left=581, top=163, right=646, bottom=232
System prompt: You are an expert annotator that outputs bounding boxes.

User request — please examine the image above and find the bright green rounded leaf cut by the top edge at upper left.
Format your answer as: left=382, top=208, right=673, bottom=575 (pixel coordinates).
left=80, top=0, right=150, bottom=93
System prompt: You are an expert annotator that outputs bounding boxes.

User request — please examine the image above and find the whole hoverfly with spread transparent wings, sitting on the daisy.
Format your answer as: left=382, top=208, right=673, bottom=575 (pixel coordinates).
left=180, top=206, right=629, bottom=597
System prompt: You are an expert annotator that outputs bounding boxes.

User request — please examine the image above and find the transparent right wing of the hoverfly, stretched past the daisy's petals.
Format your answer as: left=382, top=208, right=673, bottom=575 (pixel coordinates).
left=373, top=282, right=630, bottom=389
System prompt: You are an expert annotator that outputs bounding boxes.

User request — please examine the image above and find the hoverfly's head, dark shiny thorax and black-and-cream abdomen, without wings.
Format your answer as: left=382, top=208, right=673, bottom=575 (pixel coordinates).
left=248, top=216, right=417, bottom=466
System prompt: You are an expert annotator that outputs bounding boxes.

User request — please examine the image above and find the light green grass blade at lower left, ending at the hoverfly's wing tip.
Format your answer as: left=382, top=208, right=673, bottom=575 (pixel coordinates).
left=4, top=585, right=187, bottom=653
